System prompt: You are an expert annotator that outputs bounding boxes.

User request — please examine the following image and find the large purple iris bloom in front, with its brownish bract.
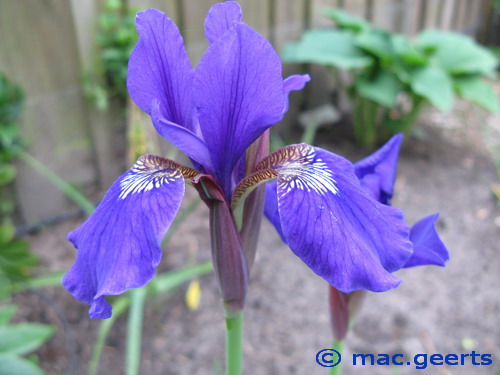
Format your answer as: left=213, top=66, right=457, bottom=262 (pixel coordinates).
left=63, top=1, right=412, bottom=318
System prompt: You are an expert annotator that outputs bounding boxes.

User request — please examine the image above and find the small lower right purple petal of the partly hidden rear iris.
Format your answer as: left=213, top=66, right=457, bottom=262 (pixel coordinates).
left=404, top=214, right=450, bottom=268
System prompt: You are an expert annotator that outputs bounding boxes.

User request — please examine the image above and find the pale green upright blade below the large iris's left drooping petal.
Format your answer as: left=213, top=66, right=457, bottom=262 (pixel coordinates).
left=125, top=288, right=147, bottom=375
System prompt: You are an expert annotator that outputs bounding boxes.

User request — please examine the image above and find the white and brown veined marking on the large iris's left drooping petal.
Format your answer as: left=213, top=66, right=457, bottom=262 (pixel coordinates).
left=118, top=155, right=199, bottom=199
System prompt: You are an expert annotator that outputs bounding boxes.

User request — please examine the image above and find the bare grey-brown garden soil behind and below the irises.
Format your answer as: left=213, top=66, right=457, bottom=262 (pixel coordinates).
left=11, top=105, right=500, bottom=375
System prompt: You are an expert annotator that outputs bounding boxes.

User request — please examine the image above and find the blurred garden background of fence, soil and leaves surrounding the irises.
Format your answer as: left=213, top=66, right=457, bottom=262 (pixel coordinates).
left=0, top=0, right=500, bottom=375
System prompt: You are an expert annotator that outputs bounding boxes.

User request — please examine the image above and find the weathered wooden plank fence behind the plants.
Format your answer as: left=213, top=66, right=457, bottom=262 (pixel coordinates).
left=0, top=0, right=491, bottom=222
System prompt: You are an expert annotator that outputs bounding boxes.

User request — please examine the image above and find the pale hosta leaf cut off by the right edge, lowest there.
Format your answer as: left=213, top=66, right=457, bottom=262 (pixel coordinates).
left=455, top=76, right=500, bottom=113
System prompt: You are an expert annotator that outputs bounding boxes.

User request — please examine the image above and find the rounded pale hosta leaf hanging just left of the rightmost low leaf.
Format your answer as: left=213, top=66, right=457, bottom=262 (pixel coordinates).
left=410, top=66, right=454, bottom=112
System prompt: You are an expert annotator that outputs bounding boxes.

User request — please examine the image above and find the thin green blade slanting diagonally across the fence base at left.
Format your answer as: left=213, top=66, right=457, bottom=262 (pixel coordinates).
left=18, top=148, right=95, bottom=215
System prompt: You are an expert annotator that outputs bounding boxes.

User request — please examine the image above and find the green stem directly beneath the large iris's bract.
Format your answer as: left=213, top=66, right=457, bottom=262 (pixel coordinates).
left=225, top=309, right=243, bottom=375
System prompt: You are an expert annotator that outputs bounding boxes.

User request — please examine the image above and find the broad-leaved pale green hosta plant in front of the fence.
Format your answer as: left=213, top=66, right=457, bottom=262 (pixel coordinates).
left=282, top=9, right=500, bottom=146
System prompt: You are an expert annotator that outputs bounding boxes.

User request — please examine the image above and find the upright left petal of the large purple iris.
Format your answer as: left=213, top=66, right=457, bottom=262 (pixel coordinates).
left=127, top=9, right=198, bottom=133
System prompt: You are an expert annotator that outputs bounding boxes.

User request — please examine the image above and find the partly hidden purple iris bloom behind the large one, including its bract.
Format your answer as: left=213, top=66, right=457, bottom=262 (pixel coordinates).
left=322, top=134, right=449, bottom=340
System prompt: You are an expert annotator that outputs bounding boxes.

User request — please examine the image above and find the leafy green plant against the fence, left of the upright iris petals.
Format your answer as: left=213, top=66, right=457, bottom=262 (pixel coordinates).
left=83, top=0, right=137, bottom=110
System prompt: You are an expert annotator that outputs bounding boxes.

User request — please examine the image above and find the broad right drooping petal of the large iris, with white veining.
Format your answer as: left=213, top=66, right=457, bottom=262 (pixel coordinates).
left=276, top=144, right=412, bottom=293
